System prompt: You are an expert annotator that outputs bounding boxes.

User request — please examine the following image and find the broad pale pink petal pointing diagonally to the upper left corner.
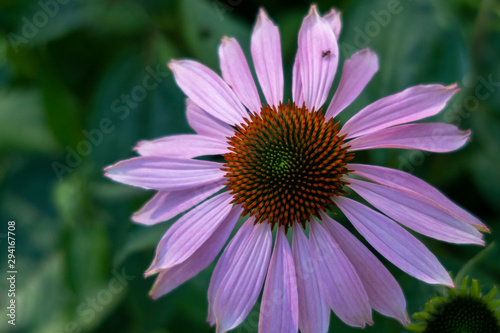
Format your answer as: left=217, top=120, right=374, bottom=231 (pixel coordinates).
left=168, top=60, right=248, bottom=125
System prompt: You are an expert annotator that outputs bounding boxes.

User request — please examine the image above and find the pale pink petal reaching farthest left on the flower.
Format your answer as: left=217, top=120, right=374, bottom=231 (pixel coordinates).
left=104, top=156, right=225, bottom=191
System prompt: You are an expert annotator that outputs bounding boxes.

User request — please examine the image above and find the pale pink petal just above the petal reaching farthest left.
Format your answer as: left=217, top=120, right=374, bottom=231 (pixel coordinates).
left=134, top=134, right=229, bottom=158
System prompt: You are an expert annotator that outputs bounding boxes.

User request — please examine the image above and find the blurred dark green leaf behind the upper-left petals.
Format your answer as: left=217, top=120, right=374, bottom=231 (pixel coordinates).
left=86, top=47, right=189, bottom=167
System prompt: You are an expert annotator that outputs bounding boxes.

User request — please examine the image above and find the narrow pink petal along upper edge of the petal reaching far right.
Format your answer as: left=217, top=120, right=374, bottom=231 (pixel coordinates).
left=347, top=164, right=489, bottom=232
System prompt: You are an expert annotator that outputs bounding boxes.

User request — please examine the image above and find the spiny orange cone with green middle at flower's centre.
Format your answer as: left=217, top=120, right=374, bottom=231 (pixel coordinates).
left=222, top=103, right=354, bottom=227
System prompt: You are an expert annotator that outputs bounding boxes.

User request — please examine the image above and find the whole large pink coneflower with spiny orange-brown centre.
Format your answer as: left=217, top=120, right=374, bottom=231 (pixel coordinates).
left=106, top=5, right=488, bottom=333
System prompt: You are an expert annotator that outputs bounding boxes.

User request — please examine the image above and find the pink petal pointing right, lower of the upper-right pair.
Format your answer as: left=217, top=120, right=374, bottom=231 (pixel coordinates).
left=349, top=123, right=470, bottom=153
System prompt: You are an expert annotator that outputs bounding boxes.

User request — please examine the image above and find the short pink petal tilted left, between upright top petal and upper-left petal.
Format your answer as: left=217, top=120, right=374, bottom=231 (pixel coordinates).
left=219, top=37, right=262, bottom=112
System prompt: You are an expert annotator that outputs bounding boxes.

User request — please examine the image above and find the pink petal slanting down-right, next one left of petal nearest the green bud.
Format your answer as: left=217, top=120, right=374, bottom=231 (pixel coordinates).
left=321, top=212, right=409, bottom=326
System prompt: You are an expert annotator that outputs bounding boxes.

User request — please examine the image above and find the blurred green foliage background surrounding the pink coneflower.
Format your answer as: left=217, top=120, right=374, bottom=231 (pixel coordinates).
left=0, top=0, right=500, bottom=333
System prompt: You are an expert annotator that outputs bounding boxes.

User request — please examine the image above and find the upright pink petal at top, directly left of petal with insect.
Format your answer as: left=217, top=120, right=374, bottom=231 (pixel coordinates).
left=251, top=8, right=283, bottom=107
